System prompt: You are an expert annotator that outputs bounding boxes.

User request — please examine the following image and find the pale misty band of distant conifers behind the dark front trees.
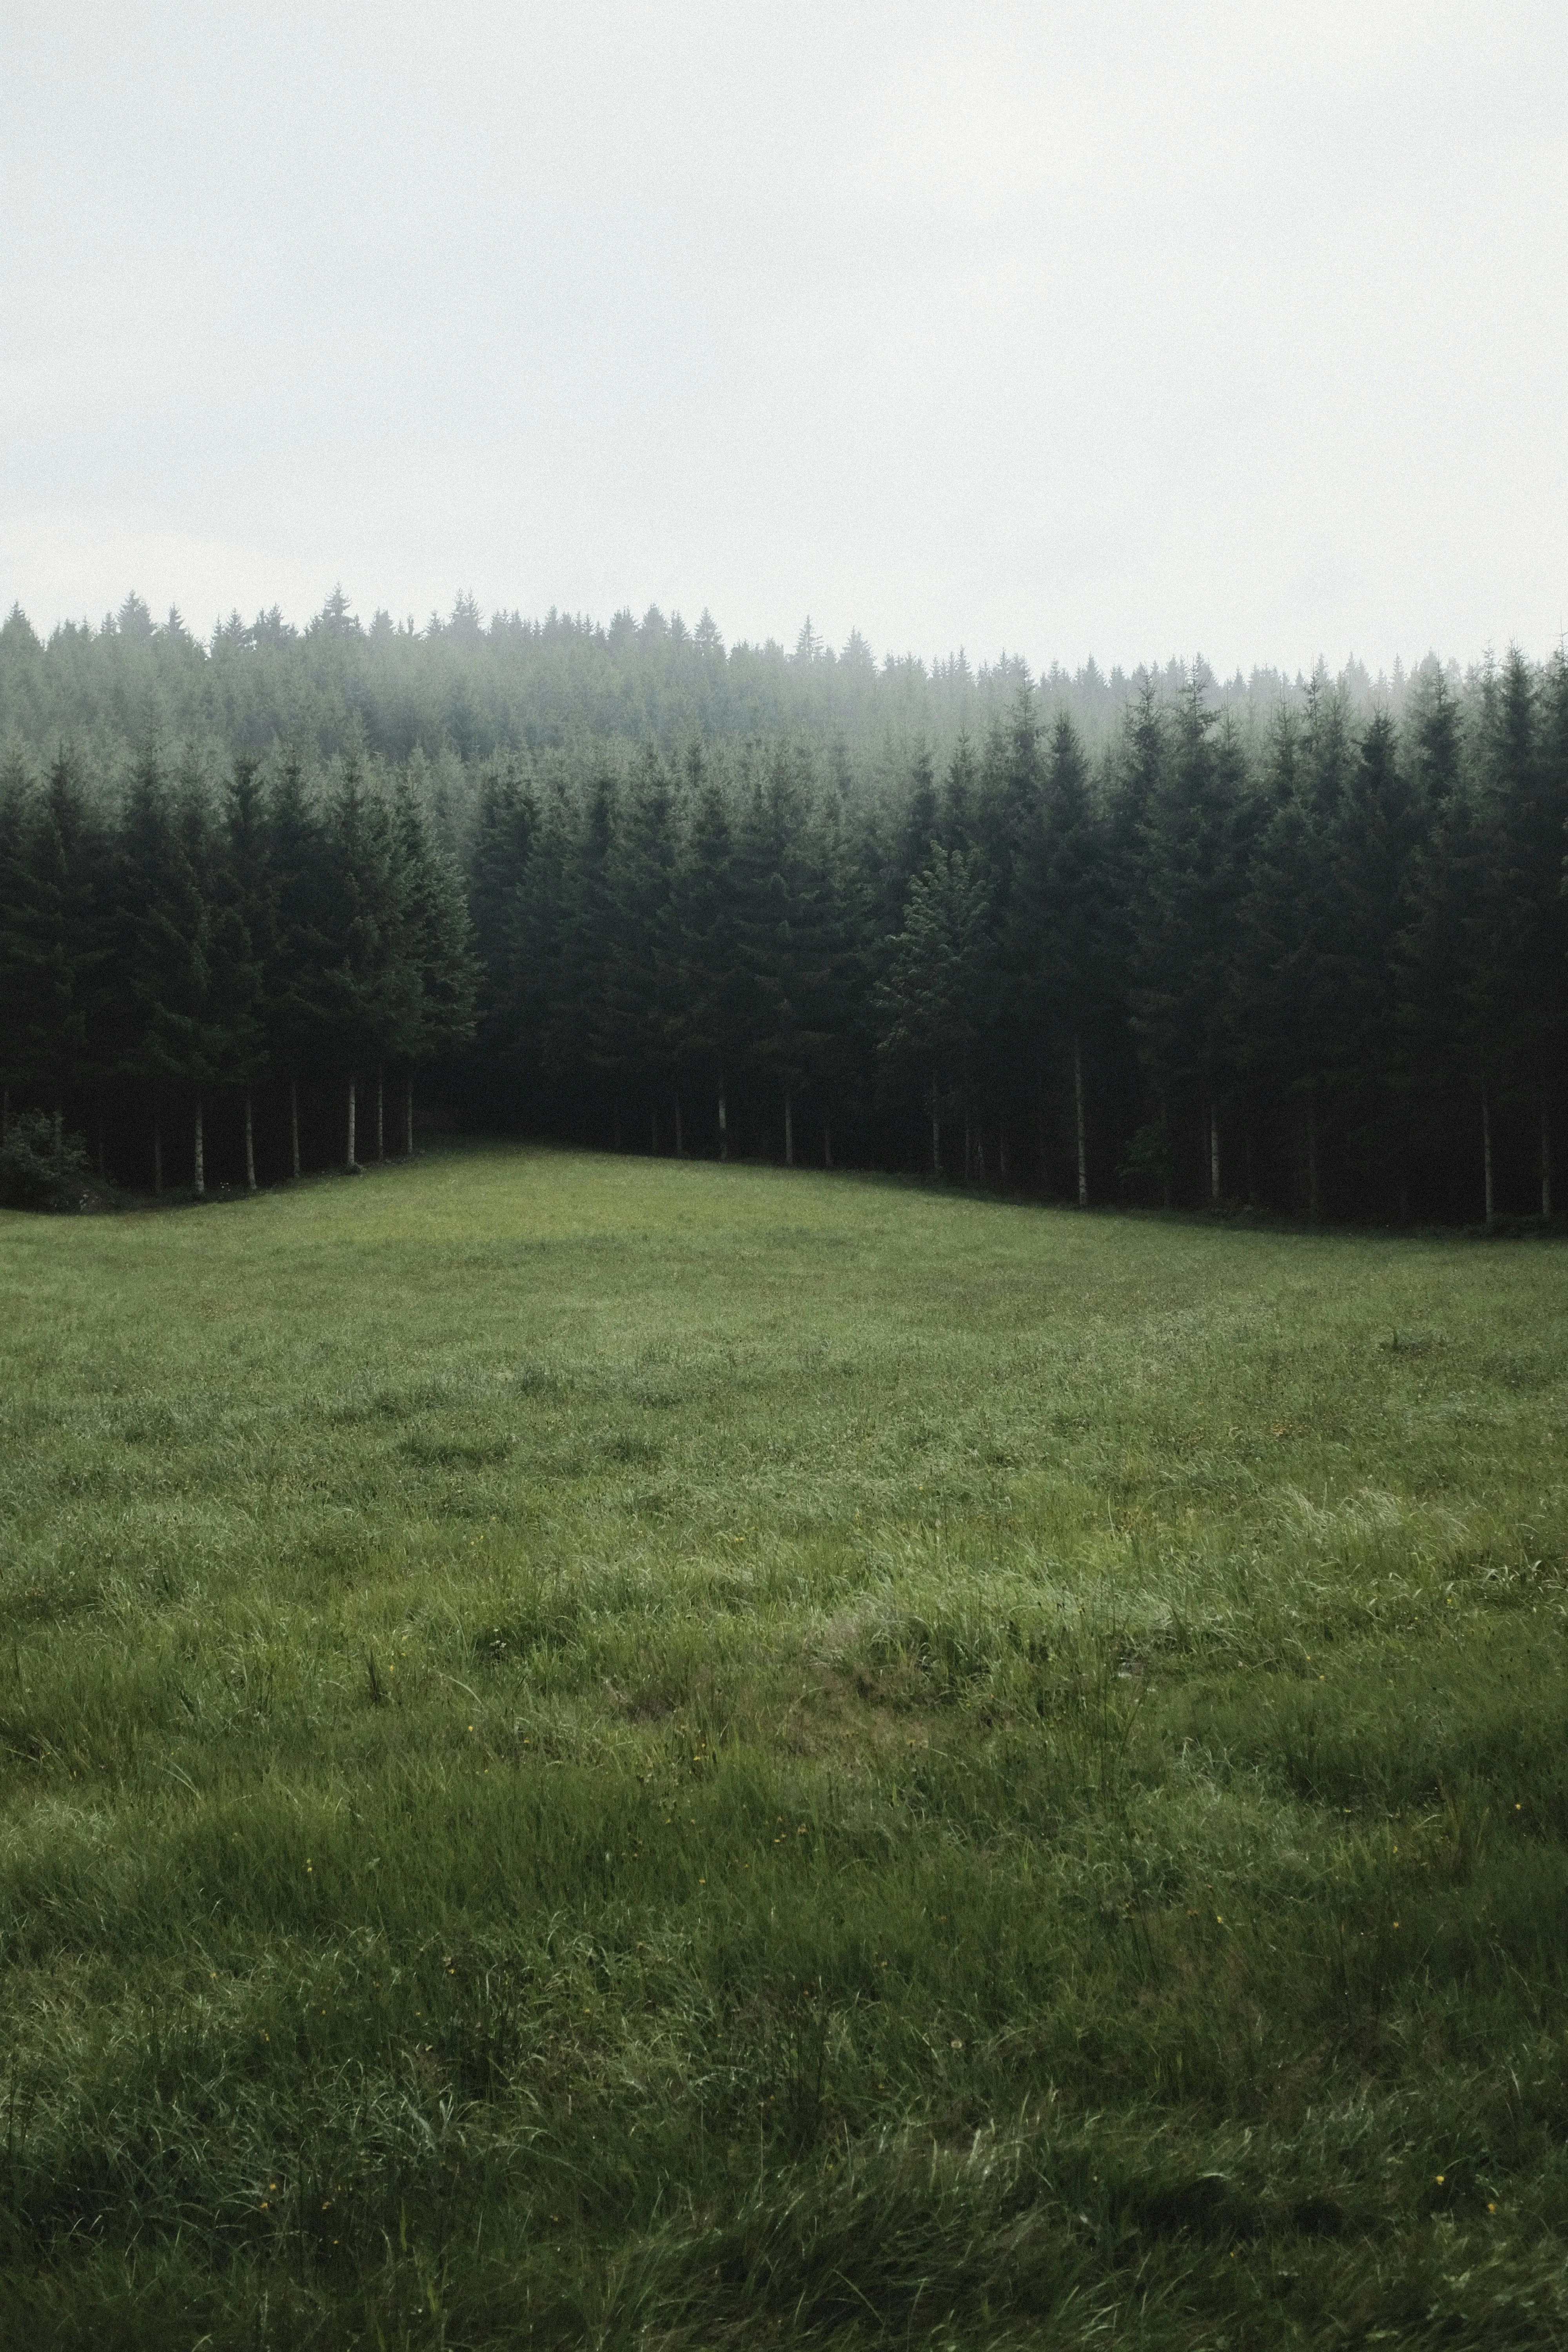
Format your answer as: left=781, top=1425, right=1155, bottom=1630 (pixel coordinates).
left=0, top=590, right=1460, bottom=767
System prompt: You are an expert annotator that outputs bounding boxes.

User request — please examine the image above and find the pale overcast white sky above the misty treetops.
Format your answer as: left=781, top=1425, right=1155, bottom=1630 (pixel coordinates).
left=0, top=0, right=1568, bottom=670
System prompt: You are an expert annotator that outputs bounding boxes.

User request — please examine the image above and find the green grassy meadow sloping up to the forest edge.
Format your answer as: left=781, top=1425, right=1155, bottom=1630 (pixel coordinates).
left=0, top=1148, right=1568, bottom=2352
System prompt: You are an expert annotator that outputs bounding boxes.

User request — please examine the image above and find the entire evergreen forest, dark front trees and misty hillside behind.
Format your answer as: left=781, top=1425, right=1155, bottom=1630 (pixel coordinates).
left=0, top=597, right=1568, bottom=1225
